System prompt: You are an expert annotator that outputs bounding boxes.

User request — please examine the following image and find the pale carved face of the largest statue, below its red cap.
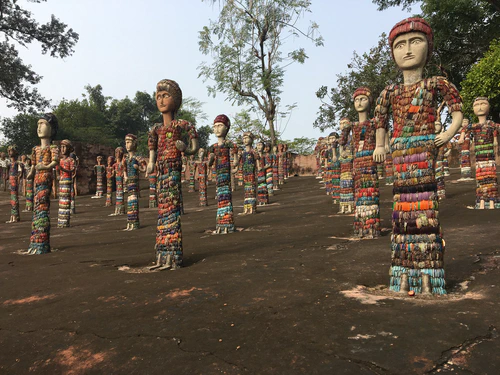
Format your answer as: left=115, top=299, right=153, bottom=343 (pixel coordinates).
left=392, top=31, right=429, bottom=70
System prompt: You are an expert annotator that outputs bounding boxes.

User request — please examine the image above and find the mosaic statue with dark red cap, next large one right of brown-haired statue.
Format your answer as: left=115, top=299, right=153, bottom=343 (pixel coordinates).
left=209, top=115, right=237, bottom=234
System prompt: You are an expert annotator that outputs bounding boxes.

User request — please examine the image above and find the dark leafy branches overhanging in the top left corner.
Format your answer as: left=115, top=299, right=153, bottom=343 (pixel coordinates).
left=0, top=0, right=78, bottom=111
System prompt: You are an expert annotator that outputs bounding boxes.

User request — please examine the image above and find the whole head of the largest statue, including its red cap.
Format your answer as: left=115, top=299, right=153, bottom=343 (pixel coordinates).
left=389, top=17, right=434, bottom=70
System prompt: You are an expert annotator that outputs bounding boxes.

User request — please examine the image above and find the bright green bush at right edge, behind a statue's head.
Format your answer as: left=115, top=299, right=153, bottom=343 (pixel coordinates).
left=461, top=39, right=500, bottom=122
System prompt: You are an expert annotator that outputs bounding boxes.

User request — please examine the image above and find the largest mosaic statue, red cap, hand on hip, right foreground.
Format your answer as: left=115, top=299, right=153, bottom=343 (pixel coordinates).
left=373, top=17, right=463, bottom=294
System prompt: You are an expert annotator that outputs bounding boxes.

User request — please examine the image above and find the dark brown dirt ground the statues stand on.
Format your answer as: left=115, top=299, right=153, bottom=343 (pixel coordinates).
left=0, top=169, right=500, bottom=375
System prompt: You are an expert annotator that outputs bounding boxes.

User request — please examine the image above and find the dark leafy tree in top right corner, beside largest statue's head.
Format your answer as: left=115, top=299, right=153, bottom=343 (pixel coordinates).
left=373, top=0, right=500, bottom=89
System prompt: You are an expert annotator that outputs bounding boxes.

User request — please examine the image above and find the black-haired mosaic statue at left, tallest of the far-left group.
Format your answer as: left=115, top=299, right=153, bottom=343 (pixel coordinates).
left=27, top=113, right=59, bottom=254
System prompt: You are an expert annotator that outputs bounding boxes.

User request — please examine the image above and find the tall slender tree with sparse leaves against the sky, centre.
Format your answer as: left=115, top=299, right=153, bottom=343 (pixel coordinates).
left=199, top=0, right=323, bottom=144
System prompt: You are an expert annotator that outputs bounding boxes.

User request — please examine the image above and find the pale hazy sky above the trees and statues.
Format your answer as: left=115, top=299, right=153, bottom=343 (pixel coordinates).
left=0, top=0, right=418, bottom=144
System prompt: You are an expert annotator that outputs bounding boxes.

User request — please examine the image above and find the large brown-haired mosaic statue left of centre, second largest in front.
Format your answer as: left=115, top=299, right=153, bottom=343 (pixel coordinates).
left=147, top=79, right=199, bottom=270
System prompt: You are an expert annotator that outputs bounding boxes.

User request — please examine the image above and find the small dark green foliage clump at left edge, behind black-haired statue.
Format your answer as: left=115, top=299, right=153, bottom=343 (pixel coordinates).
left=1, top=113, right=40, bottom=155
